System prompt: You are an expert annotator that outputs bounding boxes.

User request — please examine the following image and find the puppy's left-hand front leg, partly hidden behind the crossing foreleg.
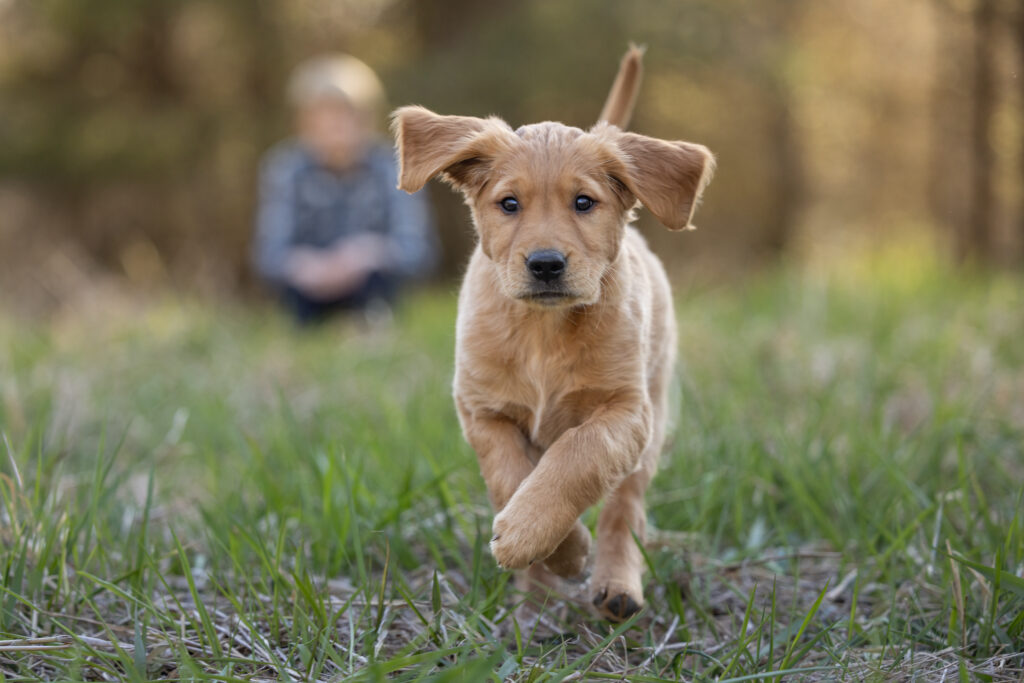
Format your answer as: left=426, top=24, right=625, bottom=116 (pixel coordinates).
left=459, top=403, right=591, bottom=578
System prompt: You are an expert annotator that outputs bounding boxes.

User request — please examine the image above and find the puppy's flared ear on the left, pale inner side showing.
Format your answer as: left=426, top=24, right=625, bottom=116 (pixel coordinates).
left=391, top=106, right=514, bottom=194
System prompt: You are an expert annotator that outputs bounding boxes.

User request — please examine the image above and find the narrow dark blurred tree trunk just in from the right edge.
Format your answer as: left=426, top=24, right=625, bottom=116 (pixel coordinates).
left=956, top=0, right=996, bottom=262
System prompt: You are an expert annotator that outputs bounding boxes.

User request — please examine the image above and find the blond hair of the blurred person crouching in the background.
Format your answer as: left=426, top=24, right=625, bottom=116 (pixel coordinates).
left=288, top=54, right=385, bottom=122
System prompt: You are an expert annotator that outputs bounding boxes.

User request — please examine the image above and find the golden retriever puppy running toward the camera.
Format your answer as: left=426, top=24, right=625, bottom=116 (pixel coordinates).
left=394, top=48, right=714, bottom=621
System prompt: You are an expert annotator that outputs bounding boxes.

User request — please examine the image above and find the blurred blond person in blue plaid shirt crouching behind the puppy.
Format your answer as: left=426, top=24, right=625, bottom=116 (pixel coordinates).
left=253, top=55, right=437, bottom=324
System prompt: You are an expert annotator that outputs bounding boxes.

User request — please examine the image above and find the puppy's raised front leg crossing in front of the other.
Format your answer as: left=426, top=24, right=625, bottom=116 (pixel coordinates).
left=490, top=394, right=651, bottom=568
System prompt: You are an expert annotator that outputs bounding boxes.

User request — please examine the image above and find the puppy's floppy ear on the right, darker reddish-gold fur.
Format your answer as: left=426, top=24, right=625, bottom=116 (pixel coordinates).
left=617, top=133, right=715, bottom=230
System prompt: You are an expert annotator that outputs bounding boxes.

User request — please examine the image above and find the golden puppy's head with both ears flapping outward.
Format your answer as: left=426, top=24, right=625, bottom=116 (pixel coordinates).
left=394, top=106, right=714, bottom=307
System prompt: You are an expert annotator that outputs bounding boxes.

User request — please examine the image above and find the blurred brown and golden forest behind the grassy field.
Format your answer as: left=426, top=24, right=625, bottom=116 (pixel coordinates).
left=0, top=0, right=1024, bottom=312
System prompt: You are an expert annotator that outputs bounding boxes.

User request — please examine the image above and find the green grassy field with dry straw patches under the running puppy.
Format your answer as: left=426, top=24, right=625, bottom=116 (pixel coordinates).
left=0, top=255, right=1024, bottom=682
